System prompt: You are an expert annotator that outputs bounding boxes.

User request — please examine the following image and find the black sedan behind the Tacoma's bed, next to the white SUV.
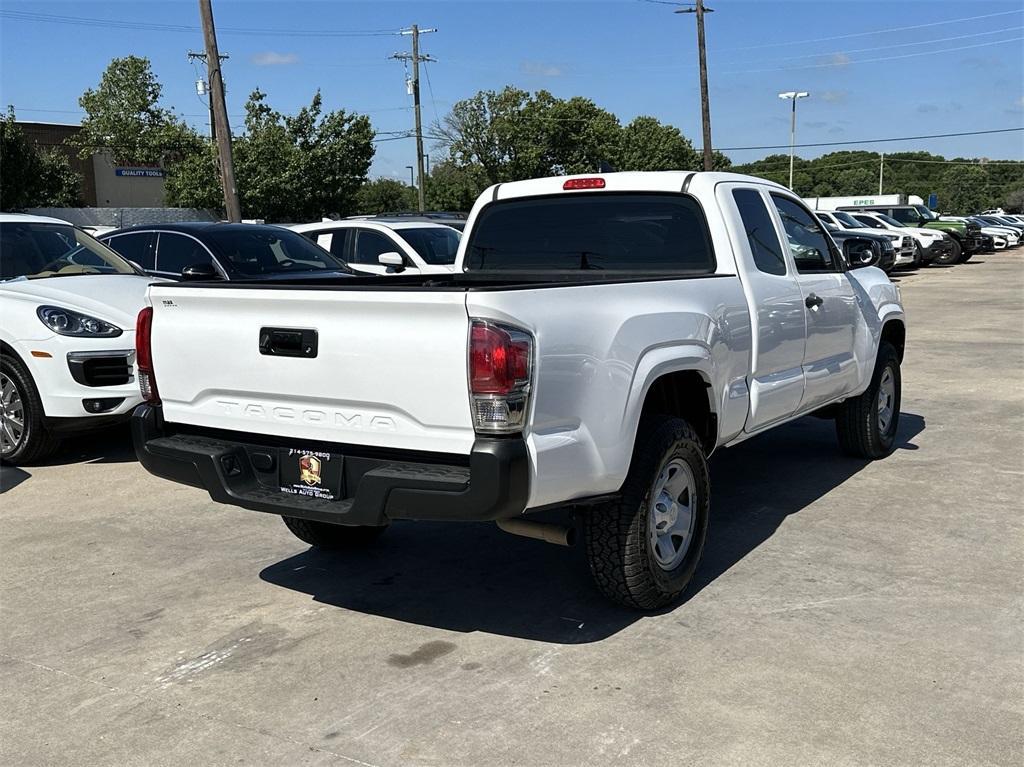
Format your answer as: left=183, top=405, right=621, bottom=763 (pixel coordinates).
left=99, top=221, right=352, bottom=280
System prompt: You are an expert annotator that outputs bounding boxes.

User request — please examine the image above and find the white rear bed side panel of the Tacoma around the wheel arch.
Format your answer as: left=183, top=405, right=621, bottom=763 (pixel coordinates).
left=467, top=276, right=750, bottom=507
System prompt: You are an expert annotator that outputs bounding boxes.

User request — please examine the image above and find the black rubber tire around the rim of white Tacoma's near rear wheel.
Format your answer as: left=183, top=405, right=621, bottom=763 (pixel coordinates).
left=583, top=416, right=711, bottom=610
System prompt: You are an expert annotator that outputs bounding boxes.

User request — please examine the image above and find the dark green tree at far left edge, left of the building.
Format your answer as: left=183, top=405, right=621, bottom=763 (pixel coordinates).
left=0, top=110, right=82, bottom=211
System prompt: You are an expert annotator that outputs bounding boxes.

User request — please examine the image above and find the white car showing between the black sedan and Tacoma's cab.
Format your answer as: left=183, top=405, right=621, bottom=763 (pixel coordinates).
left=291, top=218, right=462, bottom=274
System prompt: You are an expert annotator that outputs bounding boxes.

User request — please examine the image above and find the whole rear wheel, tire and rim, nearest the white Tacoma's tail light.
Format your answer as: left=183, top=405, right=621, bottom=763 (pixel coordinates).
left=584, top=416, right=711, bottom=610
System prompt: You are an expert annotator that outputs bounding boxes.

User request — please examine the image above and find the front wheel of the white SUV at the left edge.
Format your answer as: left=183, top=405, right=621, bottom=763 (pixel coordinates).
left=0, top=354, right=60, bottom=464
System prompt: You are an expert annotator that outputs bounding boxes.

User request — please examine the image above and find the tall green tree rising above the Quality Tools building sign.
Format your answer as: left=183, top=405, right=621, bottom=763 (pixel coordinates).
left=75, top=56, right=203, bottom=166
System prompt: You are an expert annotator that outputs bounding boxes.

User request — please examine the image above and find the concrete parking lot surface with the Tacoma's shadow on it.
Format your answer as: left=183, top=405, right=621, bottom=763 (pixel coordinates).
left=0, top=253, right=1024, bottom=767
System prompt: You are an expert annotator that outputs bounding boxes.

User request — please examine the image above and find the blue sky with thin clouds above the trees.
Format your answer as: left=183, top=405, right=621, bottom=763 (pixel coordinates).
left=0, top=0, right=1024, bottom=179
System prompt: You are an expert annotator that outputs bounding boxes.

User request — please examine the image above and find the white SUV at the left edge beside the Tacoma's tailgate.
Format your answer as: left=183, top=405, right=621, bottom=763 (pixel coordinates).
left=0, top=213, right=153, bottom=464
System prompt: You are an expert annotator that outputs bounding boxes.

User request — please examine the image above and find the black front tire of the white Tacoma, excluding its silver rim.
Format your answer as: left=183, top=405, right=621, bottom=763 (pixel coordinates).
left=836, top=341, right=902, bottom=461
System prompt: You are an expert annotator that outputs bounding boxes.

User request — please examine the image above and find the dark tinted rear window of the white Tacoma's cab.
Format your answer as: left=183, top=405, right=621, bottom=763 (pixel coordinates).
left=465, top=193, right=715, bottom=274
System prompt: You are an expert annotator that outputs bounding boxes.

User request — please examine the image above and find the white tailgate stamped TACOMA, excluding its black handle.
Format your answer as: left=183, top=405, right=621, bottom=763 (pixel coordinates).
left=151, top=283, right=474, bottom=454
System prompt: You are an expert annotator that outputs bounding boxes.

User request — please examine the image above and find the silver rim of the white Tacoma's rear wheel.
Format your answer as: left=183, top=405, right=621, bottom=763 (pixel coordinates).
left=648, top=458, right=697, bottom=570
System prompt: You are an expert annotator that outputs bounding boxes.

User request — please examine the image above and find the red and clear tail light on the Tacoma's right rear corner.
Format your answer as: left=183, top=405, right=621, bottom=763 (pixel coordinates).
left=469, top=319, right=534, bottom=433
